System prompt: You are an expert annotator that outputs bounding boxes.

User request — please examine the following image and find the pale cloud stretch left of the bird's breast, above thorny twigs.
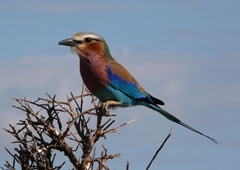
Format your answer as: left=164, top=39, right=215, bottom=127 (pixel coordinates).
left=0, top=56, right=80, bottom=95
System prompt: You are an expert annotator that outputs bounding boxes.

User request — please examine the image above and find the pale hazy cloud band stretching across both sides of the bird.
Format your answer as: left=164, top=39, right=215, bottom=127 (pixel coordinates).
left=0, top=49, right=240, bottom=125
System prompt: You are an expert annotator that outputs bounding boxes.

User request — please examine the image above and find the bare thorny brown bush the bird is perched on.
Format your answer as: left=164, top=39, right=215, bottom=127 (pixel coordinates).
left=2, top=85, right=171, bottom=170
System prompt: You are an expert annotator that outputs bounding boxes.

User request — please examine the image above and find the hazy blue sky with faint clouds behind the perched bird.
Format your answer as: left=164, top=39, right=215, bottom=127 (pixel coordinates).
left=0, top=0, right=240, bottom=170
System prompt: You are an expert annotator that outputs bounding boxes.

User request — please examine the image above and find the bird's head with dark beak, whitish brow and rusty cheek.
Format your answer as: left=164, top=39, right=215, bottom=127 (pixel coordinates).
left=58, top=32, right=112, bottom=59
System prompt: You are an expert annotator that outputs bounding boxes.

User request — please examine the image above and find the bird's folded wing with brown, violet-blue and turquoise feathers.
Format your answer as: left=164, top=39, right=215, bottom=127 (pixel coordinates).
left=94, top=60, right=164, bottom=106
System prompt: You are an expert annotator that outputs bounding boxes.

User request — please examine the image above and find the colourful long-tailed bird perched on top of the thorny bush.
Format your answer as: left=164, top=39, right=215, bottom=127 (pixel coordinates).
left=58, top=31, right=218, bottom=144
